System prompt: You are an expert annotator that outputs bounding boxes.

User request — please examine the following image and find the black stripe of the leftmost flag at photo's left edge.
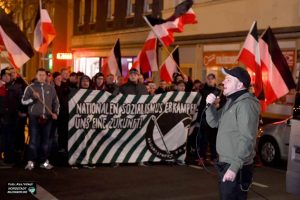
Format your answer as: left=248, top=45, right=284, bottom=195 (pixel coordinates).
left=0, top=12, right=34, bottom=58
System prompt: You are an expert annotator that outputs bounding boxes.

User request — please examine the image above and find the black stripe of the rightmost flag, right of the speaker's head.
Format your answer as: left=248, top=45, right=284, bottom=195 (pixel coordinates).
left=261, top=27, right=296, bottom=89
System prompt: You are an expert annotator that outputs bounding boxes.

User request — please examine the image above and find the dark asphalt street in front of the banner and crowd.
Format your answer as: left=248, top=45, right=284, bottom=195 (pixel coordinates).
left=0, top=165, right=299, bottom=200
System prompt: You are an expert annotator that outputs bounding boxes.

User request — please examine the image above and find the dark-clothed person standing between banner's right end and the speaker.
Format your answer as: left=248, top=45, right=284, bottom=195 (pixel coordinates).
left=197, top=74, right=218, bottom=165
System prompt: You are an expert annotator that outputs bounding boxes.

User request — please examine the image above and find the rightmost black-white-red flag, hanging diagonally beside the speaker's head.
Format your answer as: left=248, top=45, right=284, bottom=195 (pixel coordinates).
left=259, top=27, right=296, bottom=105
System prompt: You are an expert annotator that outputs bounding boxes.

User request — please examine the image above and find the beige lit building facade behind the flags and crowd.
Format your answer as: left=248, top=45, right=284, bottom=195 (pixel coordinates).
left=68, top=0, right=300, bottom=115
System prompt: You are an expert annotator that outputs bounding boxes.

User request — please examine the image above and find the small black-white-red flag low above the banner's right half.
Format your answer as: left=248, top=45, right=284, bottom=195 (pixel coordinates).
left=160, top=48, right=179, bottom=83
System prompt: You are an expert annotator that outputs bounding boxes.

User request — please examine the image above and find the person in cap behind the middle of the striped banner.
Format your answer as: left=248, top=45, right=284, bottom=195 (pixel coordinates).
left=120, top=68, right=148, bottom=95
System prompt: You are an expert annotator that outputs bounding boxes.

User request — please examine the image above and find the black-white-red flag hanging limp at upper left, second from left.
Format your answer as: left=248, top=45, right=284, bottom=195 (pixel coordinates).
left=33, top=0, right=56, bottom=53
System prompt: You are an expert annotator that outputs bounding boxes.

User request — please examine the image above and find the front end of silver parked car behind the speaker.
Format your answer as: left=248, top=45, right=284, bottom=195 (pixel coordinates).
left=256, top=118, right=291, bottom=166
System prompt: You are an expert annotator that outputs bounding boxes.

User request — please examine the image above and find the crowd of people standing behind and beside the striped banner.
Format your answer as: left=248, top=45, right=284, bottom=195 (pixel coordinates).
left=0, top=65, right=239, bottom=170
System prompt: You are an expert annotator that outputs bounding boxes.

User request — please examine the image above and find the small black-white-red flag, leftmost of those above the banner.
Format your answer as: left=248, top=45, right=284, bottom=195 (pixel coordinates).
left=102, top=39, right=122, bottom=77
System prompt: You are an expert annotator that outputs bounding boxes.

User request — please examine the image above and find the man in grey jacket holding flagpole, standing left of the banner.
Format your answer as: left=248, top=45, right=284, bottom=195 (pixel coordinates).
left=22, top=68, right=59, bottom=170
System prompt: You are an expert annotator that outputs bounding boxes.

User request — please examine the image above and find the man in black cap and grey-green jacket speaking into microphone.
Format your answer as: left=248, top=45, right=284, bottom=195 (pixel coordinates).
left=206, top=67, right=260, bottom=200
